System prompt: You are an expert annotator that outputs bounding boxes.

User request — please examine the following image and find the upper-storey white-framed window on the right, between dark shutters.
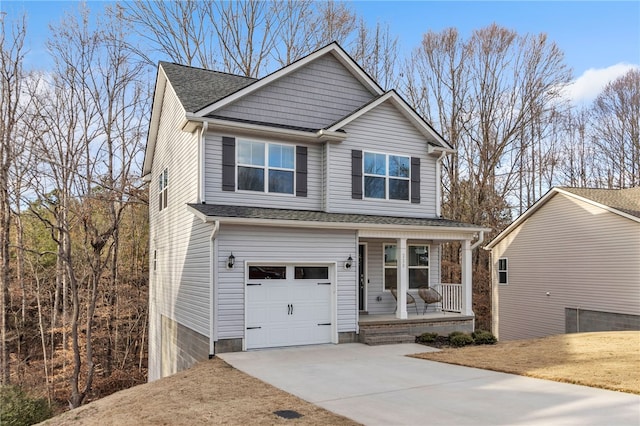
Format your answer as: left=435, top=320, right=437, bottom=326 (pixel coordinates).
left=363, top=152, right=411, bottom=200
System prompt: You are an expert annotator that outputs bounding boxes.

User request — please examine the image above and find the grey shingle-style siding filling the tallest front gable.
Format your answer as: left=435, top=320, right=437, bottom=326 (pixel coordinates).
left=213, top=54, right=373, bottom=129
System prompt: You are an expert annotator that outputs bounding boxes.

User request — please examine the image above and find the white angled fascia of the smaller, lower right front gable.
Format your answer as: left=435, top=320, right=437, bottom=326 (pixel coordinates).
left=328, top=90, right=455, bottom=152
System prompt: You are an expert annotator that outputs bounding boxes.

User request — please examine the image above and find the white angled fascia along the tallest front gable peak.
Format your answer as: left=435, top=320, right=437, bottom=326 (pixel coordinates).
left=195, top=42, right=384, bottom=117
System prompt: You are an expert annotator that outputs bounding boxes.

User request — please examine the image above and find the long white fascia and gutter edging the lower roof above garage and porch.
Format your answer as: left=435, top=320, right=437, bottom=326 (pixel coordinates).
left=187, top=206, right=491, bottom=240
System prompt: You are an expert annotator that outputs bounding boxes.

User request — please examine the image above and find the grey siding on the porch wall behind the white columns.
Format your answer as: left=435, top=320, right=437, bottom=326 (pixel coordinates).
left=360, top=239, right=440, bottom=315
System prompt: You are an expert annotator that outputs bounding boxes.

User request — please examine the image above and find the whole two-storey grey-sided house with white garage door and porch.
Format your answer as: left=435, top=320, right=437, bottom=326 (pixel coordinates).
left=143, top=43, right=486, bottom=380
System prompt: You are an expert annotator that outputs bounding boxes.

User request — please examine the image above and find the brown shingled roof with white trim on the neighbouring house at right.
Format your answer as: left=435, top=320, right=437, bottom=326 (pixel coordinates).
left=485, top=187, right=640, bottom=249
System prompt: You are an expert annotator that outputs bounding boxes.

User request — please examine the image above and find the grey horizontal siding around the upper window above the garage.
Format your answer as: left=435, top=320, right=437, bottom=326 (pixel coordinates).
left=204, top=133, right=323, bottom=210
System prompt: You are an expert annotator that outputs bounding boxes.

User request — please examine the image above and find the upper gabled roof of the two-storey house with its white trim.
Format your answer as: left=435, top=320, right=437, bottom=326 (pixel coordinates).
left=142, top=42, right=454, bottom=177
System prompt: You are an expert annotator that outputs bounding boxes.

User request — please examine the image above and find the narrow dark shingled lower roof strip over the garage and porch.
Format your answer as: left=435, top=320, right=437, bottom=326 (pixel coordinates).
left=189, top=204, right=480, bottom=229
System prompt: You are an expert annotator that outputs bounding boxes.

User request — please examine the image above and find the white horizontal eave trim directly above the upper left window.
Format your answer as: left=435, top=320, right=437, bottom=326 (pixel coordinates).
left=180, top=114, right=348, bottom=142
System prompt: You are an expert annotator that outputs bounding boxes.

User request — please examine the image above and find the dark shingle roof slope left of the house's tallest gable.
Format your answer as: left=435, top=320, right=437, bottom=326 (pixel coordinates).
left=160, top=62, right=256, bottom=112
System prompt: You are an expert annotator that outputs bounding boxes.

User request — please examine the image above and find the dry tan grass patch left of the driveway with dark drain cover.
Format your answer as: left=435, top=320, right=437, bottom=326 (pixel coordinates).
left=45, top=359, right=358, bottom=426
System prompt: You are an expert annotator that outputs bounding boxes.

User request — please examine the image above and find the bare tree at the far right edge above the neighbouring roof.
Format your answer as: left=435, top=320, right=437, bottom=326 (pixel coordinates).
left=591, top=69, right=640, bottom=188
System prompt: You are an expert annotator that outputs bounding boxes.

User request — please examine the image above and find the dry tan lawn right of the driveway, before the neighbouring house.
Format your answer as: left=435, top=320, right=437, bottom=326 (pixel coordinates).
left=413, top=331, right=640, bottom=394
